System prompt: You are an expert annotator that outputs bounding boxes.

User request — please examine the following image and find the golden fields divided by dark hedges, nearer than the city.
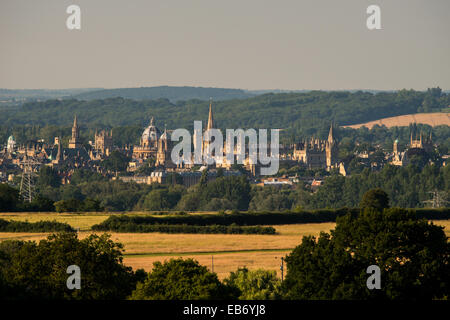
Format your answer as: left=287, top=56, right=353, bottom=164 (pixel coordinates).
left=0, top=213, right=450, bottom=279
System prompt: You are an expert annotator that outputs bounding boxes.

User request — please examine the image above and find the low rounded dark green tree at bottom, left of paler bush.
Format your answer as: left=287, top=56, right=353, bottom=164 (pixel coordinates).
left=130, top=258, right=239, bottom=300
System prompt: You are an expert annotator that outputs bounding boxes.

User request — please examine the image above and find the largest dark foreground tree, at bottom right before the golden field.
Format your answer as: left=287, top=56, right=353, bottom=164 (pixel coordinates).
left=283, top=208, right=450, bottom=299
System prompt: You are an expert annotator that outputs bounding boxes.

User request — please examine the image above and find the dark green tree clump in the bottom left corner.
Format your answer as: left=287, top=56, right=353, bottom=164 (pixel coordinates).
left=0, top=233, right=138, bottom=300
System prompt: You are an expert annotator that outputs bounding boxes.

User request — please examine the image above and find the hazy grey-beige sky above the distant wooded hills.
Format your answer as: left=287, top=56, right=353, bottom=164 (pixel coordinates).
left=0, top=0, right=450, bottom=90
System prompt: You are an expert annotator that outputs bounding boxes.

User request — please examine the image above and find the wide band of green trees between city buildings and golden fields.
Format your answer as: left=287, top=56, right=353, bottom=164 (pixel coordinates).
left=0, top=160, right=450, bottom=212
